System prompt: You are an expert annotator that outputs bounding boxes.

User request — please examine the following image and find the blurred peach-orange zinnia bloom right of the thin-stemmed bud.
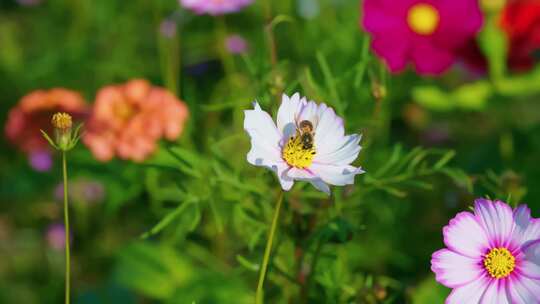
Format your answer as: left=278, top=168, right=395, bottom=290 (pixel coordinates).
left=83, top=79, right=189, bottom=161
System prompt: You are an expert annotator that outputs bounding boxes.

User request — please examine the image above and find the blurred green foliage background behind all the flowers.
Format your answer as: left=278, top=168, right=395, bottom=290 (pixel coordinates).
left=0, top=0, right=540, bottom=304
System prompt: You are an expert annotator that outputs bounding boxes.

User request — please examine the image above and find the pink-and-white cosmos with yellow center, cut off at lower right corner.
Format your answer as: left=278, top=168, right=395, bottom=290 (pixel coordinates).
left=431, top=199, right=540, bottom=304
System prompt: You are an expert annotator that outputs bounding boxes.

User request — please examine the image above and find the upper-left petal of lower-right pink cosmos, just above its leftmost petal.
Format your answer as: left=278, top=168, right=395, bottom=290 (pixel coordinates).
left=443, top=211, right=489, bottom=258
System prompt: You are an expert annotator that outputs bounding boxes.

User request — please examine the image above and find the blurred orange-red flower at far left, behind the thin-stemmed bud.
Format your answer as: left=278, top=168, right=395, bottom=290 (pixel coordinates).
left=5, top=88, right=87, bottom=153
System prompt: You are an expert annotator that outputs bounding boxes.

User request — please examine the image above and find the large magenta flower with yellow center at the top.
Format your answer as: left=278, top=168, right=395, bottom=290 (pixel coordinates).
left=362, top=0, right=482, bottom=75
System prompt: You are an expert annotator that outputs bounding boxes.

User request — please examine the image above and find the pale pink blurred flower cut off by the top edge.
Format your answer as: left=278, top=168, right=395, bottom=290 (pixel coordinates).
left=180, top=0, right=253, bottom=16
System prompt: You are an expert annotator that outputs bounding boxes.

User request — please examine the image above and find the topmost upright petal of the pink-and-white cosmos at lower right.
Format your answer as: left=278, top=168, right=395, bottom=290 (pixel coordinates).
left=474, top=199, right=514, bottom=247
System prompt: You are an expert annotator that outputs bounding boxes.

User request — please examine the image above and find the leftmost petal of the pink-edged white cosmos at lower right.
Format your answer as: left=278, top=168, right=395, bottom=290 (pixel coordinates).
left=431, top=249, right=483, bottom=288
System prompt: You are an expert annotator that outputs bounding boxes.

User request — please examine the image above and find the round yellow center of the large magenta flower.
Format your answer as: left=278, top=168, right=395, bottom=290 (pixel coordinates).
left=407, top=3, right=440, bottom=35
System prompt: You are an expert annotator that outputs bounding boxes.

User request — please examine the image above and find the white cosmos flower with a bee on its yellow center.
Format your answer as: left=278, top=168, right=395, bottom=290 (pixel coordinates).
left=244, top=93, right=364, bottom=194
